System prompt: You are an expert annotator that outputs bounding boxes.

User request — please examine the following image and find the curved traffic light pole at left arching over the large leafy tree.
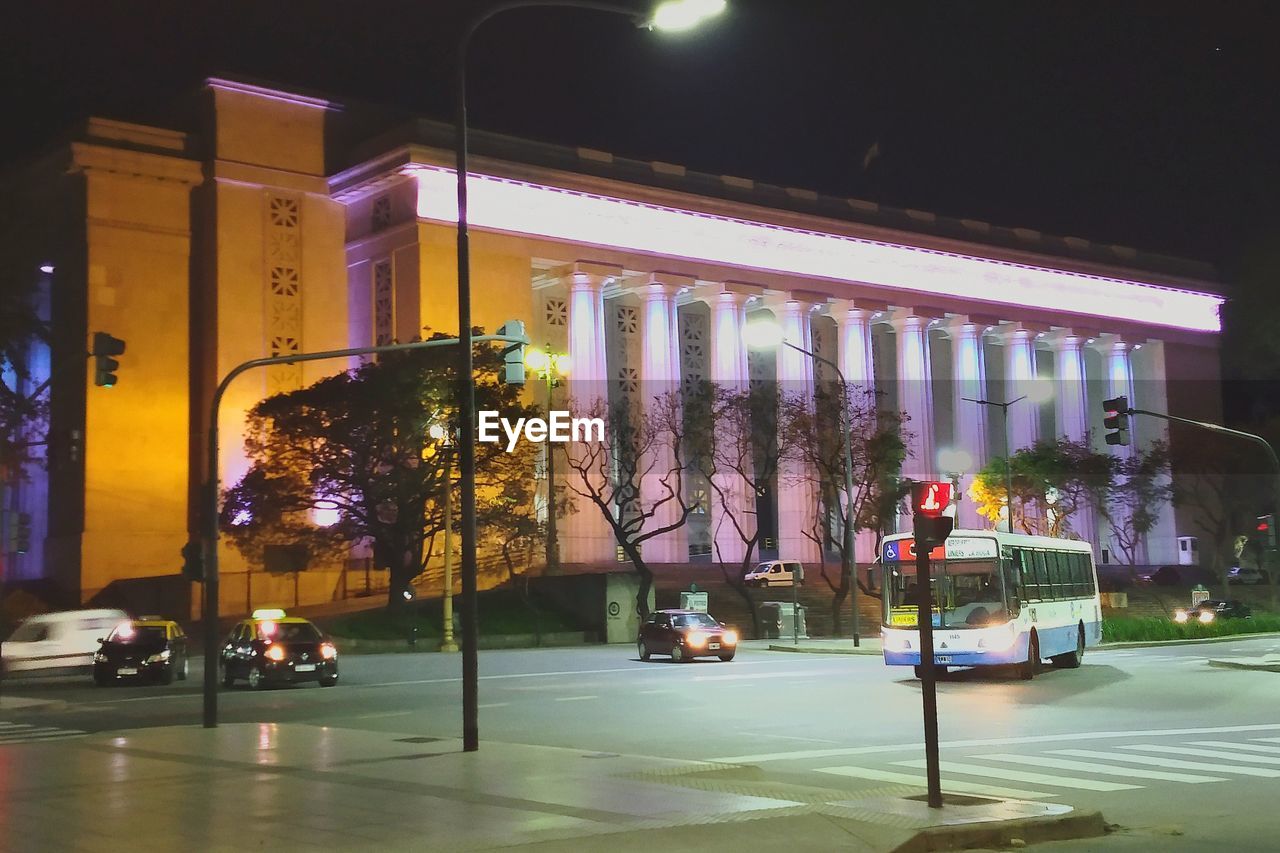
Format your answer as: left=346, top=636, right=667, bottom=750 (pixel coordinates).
left=201, top=334, right=529, bottom=729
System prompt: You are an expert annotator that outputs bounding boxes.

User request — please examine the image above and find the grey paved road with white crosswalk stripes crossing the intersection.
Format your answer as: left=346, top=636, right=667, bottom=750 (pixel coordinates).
left=0, top=638, right=1280, bottom=850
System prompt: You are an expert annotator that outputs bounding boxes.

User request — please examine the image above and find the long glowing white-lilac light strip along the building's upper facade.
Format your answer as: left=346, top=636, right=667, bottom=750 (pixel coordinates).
left=410, top=167, right=1224, bottom=332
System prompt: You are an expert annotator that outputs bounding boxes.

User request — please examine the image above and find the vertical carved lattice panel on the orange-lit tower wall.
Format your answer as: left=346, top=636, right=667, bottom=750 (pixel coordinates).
left=265, top=195, right=302, bottom=394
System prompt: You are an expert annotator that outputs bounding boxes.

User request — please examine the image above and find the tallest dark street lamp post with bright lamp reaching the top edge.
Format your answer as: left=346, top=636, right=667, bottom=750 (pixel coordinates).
left=453, top=0, right=726, bottom=752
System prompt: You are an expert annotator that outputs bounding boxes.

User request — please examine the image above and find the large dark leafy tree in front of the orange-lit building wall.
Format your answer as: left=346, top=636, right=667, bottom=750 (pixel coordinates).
left=220, top=333, right=535, bottom=605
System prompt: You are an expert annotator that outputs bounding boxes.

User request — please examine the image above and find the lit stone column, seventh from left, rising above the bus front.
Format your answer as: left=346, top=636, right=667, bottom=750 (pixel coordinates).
left=941, top=316, right=988, bottom=529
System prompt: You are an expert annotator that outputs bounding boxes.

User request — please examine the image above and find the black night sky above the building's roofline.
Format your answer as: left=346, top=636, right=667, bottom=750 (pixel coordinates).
left=0, top=0, right=1280, bottom=268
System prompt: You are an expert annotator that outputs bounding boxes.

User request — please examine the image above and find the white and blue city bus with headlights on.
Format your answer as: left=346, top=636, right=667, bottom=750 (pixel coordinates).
left=881, top=530, right=1102, bottom=679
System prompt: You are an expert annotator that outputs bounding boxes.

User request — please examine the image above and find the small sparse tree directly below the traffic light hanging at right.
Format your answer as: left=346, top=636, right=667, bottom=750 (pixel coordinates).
left=1101, top=441, right=1174, bottom=573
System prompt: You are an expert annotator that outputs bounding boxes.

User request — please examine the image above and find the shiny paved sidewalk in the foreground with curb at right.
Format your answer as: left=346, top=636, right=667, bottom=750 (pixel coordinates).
left=0, top=724, right=1103, bottom=853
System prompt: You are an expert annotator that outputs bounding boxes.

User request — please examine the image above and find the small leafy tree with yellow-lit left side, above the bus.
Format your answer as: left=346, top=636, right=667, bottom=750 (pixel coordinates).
left=969, top=435, right=1117, bottom=538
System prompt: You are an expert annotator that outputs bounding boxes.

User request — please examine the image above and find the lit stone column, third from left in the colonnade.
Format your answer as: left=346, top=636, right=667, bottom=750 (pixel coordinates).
left=709, top=286, right=755, bottom=564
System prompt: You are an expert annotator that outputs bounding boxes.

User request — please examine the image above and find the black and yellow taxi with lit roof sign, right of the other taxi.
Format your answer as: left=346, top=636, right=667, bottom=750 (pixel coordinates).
left=218, top=610, right=338, bottom=689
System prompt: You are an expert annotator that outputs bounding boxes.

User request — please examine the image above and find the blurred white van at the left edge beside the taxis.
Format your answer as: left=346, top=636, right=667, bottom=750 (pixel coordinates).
left=3, top=610, right=128, bottom=674
